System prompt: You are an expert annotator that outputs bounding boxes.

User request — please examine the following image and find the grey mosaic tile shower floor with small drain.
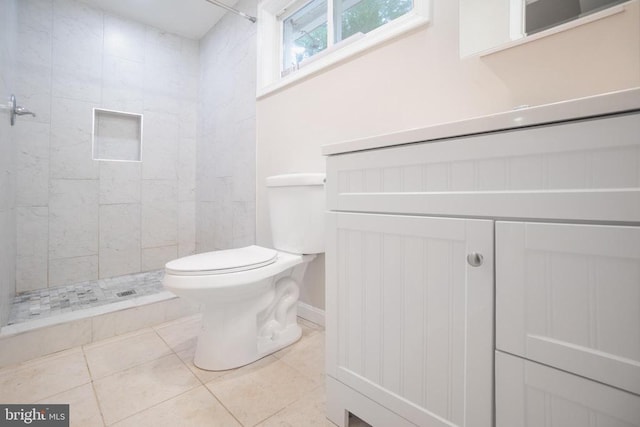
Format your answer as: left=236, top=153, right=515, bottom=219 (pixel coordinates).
left=7, top=270, right=163, bottom=325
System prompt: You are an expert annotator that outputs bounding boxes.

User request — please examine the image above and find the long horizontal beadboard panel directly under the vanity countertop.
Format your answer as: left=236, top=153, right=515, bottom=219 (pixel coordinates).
left=327, top=112, right=640, bottom=221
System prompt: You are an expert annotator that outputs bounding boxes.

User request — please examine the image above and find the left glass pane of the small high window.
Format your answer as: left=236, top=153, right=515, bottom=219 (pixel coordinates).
left=282, top=0, right=327, bottom=74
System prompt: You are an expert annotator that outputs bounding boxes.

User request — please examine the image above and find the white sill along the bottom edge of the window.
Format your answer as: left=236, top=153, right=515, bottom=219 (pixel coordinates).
left=256, top=12, right=429, bottom=99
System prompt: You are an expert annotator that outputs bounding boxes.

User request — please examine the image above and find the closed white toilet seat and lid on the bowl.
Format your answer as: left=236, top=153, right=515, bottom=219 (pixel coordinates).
left=165, top=245, right=278, bottom=276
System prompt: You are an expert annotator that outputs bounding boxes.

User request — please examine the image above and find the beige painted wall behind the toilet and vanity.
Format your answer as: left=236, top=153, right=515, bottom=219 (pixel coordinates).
left=256, top=0, right=640, bottom=308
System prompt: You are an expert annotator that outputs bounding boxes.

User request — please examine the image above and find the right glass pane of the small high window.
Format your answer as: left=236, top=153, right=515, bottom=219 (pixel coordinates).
left=334, top=0, right=413, bottom=42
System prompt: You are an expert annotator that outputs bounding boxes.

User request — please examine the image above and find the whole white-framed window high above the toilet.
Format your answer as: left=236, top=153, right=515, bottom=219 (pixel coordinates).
left=258, top=0, right=429, bottom=96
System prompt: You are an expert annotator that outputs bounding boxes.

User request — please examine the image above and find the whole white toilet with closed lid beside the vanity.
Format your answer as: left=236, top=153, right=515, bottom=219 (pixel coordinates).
left=163, top=174, right=325, bottom=371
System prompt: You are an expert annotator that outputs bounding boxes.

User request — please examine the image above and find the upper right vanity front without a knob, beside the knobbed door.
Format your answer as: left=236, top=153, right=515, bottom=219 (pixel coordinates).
left=496, top=222, right=640, bottom=394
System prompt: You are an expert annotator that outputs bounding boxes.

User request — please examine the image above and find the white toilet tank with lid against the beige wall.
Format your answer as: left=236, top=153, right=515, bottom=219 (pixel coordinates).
left=267, top=173, right=326, bottom=254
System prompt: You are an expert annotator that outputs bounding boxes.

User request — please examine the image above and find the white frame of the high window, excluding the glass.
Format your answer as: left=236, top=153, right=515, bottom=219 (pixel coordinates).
left=256, top=0, right=431, bottom=98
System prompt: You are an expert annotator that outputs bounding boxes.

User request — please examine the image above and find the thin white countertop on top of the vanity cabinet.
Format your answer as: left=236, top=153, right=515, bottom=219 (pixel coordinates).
left=322, top=87, right=640, bottom=156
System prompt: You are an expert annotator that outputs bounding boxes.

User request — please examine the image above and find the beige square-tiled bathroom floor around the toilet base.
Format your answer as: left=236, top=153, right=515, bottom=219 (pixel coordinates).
left=0, top=315, right=352, bottom=427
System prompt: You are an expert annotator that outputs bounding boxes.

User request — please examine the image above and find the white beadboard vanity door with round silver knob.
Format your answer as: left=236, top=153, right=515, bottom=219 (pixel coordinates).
left=326, top=213, right=494, bottom=427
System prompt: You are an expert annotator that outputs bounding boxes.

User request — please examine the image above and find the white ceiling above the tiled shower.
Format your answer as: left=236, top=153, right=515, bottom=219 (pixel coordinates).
left=82, top=0, right=241, bottom=40
